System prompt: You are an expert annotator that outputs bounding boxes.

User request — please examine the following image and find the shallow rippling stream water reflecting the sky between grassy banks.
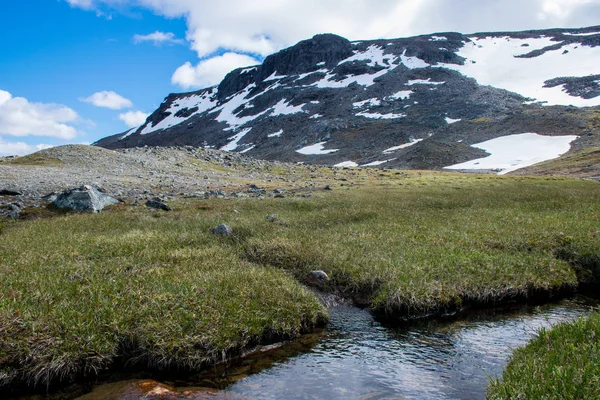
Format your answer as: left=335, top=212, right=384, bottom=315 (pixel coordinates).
left=76, top=298, right=592, bottom=400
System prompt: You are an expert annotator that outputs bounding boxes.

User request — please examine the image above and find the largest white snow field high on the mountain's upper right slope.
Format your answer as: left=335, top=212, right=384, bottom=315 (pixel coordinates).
left=436, top=36, right=600, bottom=107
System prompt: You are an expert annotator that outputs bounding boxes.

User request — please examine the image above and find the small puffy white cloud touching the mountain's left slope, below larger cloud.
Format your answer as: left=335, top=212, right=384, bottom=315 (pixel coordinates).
left=171, top=53, right=260, bottom=89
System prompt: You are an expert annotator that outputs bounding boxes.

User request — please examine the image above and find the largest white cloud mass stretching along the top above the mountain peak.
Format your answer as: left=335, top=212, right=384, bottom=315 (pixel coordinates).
left=67, top=0, right=600, bottom=88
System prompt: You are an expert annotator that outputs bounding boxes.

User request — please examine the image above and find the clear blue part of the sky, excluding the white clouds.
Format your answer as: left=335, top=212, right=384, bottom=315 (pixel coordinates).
left=0, top=0, right=197, bottom=155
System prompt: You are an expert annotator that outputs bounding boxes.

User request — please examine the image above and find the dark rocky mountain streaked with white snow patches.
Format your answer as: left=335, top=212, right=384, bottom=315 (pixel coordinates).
left=95, top=26, right=600, bottom=172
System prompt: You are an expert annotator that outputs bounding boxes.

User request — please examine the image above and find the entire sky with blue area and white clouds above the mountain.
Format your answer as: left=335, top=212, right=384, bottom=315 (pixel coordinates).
left=0, top=0, right=600, bottom=156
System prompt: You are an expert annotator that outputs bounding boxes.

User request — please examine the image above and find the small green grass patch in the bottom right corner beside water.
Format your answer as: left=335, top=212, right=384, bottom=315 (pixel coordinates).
left=488, top=312, right=600, bottom=400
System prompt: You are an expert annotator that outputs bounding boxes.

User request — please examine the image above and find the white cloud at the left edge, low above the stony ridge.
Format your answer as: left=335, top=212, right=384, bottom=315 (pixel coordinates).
left=0, top=90, right=79, bottom=140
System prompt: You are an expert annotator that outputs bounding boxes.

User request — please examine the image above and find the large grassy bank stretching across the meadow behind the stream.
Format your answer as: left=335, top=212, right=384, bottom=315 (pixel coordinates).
left=0, top=173, right=600, bottom=390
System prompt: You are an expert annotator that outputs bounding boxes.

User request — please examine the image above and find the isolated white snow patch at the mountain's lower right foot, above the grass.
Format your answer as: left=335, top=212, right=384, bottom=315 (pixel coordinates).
left=444, top=133, right=578, bottom=175
